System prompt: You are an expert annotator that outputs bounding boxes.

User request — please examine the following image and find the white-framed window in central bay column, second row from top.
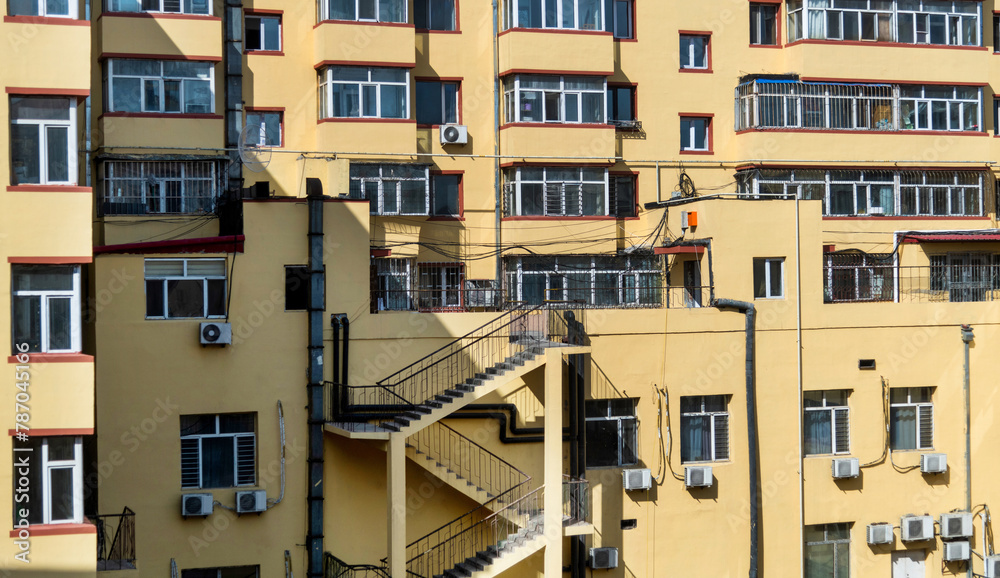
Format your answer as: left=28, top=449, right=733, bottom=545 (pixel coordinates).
left=503, top=74, right=608, bottom=124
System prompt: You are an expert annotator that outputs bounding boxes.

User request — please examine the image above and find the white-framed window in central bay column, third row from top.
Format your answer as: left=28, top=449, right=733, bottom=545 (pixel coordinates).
left=505, top=167, right=611, bottom=218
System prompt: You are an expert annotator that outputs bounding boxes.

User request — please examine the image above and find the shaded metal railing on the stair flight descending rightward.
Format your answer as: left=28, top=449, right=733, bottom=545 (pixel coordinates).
left=406, top=422, right=531, bottom=499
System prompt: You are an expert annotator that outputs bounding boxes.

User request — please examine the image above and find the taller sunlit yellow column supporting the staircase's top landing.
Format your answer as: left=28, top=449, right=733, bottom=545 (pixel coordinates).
left=543, top=347, right=563, bottom=576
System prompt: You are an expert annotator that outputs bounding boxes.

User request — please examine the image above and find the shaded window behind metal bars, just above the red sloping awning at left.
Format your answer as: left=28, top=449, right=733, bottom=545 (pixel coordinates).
left=102, top=161, right=221, bottom=215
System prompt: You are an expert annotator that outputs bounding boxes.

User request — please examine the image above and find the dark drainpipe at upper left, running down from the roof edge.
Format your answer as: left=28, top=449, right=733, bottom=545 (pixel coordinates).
left=223, top=0, right=243, bottom=191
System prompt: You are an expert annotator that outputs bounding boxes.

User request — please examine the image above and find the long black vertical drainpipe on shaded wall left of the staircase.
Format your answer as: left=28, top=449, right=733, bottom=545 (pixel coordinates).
left=306, top=178, right=326, bottom=578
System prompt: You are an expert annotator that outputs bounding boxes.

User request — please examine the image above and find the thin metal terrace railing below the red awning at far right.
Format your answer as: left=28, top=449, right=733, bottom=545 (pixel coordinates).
left=824, top=263, right=1000, bottom=303
